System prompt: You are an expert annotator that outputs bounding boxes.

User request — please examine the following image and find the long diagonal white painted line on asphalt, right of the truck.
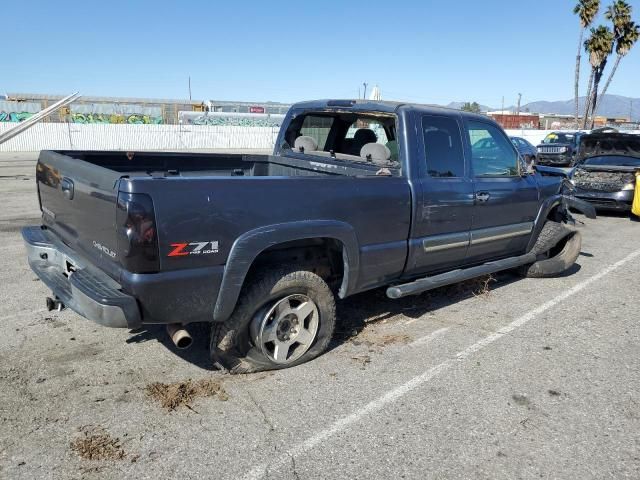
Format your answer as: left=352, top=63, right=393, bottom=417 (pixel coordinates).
left=244, top=250, right=640, bottom=480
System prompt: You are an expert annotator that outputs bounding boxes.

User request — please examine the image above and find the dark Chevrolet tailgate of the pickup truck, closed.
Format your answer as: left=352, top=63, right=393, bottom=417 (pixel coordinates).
left=36, top=151, right=122, bottom=280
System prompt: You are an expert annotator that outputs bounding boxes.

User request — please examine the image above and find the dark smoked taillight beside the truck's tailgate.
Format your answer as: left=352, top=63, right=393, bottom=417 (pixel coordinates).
left=116, top=192, right=160, bottom=273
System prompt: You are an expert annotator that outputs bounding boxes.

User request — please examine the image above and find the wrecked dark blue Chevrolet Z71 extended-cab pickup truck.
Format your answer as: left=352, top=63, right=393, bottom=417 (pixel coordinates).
left=22, top=100, right=594, bottom=373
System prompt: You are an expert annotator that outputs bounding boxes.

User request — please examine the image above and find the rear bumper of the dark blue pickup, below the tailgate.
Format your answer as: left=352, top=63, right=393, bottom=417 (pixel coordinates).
left=22, top=226, right=142, bottom=328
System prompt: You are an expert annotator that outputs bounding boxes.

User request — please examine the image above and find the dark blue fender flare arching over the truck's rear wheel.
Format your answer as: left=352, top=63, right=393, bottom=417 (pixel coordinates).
left=213, top=220, right=360, bottom=322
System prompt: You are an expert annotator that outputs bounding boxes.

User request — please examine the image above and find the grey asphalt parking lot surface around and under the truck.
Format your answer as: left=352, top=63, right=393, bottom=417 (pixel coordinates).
left=0, top=154, right=640, bottom=480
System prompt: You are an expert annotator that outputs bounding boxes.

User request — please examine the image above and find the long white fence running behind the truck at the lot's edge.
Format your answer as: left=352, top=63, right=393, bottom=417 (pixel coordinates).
left=0, top=123, right=640, bottom=152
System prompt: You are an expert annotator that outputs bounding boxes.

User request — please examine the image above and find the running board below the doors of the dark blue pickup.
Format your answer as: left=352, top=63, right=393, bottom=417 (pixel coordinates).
left=387, top=252, right=537, bottom=299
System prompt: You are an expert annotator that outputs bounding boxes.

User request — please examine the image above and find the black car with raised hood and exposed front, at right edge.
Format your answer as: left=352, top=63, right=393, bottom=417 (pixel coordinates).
left=571, top=133, right=640, bottom=211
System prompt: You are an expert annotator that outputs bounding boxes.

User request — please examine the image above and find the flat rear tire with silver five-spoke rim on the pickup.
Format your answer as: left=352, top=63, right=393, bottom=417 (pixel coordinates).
left=210, top=266, right=336, bottom=374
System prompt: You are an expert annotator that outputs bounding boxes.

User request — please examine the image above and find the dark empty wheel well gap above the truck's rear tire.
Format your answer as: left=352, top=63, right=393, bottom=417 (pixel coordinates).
left=247, top=238, right=344, bottom=291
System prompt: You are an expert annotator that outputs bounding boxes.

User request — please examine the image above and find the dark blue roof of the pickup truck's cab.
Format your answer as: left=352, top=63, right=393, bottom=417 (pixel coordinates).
left=291, top=99, right=494, bottom=122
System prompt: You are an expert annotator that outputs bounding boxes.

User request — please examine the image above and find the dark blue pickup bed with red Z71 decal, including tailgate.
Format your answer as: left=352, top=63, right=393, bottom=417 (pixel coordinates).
left=36, top=151, right=411, bottom=323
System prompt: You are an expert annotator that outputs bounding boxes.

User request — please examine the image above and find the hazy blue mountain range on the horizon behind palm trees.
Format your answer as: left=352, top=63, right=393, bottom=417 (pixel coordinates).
left=447, top=95, right=640, bottom=121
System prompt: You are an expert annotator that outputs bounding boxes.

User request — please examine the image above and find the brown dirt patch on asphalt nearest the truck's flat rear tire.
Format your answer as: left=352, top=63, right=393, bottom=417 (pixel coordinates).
left=146, top=378, right=229, bottom=411
